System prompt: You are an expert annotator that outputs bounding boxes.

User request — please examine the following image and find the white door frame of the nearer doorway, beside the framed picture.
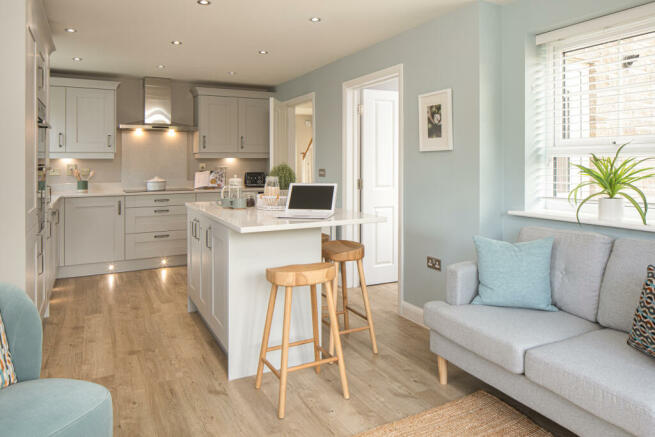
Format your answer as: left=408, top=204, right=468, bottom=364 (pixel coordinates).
left=341, top=64, right=405, bottom=314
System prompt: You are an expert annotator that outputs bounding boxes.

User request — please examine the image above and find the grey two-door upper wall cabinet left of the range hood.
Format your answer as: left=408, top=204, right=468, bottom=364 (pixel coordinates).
left=50, top=77, right=119, bottom=159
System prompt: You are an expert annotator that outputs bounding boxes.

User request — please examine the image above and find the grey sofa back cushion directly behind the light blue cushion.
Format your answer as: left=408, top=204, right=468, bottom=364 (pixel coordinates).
left=518, top=226, right=613, bottom=322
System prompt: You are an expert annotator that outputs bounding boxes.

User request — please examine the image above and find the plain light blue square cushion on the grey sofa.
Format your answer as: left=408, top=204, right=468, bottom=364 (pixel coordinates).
left=472, top=236, right=557, bottom=311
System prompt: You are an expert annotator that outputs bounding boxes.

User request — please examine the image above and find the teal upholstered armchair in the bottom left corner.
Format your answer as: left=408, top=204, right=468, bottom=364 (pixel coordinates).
left=0, top=284, right=113, bottom=437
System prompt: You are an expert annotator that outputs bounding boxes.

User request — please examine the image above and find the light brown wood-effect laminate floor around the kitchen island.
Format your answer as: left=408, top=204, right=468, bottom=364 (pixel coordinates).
left=42, top=267, right=568, bottom=437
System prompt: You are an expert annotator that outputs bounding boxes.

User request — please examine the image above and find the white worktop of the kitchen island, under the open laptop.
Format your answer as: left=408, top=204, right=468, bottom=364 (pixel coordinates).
left=186, top=202, right=386, bottom=234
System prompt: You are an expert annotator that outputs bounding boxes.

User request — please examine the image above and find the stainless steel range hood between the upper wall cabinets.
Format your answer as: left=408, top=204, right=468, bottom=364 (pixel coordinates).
left=118, top=77, right=196, bottom=132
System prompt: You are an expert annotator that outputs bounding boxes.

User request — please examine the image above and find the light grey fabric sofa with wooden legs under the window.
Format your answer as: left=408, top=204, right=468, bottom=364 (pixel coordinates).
left=424, top=227, right=655, bottom=436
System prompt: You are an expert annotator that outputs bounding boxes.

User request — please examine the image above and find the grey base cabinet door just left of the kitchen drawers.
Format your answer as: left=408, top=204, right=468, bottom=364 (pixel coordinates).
left=64, top=196, right=125, bottom=266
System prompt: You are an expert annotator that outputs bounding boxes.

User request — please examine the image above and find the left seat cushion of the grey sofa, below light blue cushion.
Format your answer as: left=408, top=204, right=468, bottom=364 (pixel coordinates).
left=423, top=301, right=599, bottom=374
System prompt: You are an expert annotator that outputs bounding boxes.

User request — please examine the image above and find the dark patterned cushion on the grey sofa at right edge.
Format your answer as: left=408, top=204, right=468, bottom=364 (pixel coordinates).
left=628, top=265, right=655, bottom=357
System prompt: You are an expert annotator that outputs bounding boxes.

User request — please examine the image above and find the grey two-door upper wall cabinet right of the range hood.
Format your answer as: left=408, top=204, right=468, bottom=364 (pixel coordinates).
left=191, top=87, right=270, bottom=158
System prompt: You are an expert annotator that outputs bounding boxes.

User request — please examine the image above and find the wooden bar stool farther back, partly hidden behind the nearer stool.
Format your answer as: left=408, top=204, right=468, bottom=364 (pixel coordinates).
left=322, top=240, right=378, bottom=354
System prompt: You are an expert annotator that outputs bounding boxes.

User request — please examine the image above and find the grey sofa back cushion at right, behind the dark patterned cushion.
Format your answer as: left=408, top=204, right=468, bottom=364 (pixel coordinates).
left=598, top=238, right=655, bottom=332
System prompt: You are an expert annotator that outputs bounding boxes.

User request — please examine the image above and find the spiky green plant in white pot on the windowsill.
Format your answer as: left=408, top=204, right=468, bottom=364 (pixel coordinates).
left=569, top=143, right=655, bottom=224
